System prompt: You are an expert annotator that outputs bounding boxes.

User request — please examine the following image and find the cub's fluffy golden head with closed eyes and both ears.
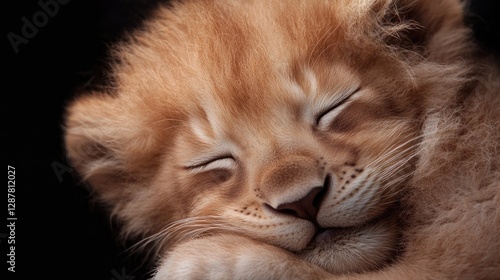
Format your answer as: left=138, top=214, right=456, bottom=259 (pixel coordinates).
left=65, top=0, right=472, bottom=272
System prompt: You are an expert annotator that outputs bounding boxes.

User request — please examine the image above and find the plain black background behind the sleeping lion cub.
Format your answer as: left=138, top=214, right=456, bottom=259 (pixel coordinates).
left=0, top=0, right=500, bottom=280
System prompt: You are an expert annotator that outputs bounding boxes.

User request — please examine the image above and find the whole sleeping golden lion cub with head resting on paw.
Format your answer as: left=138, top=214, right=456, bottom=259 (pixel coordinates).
left=65, top=0, right=500, bottom=279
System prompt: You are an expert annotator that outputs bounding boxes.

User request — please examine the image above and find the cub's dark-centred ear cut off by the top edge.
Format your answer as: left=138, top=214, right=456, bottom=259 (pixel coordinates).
left=370, top=0, right=470, bottom=59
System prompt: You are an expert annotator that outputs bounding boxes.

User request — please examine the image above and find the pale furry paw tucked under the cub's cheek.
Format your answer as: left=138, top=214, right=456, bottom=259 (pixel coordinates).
left=153, top=235, right=329, bottom=280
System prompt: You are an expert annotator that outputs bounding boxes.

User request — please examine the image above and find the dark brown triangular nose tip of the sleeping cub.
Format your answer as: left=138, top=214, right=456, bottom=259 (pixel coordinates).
left=276, top=186, right=324, bottom=223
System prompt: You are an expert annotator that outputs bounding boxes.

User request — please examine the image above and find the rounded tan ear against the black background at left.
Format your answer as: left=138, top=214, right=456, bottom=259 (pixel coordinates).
left=64, top=93, right=158, bottom=205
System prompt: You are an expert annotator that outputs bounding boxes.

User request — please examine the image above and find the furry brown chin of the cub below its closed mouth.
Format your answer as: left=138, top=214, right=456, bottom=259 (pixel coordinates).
left=298, top=212, right=401, bottom=274
